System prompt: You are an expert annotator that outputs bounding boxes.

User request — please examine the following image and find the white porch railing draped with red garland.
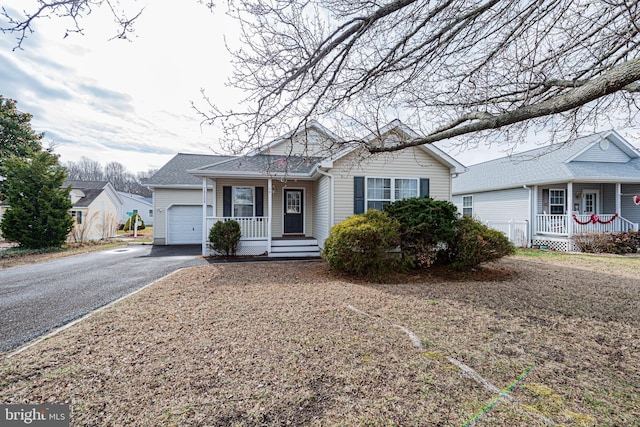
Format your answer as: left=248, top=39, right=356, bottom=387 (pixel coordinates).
left=535, top=214, right=638, bottom=236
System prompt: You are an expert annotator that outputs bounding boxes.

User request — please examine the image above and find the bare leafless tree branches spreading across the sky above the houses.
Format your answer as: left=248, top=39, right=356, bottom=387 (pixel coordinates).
left=204, top=0, right=640, bottom=152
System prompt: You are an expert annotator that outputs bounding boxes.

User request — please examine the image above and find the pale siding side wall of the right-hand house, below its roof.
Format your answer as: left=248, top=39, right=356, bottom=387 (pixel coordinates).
left=454, top=188, right=530, bottom=221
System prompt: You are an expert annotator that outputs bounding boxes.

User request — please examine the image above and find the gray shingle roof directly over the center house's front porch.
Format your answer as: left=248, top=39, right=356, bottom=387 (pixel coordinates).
left=192, top=154, right=322, bottom=175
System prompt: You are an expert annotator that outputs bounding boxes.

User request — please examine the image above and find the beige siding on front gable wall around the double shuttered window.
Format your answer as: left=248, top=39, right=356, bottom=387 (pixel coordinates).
left=330, top=147, right=451, bottom=223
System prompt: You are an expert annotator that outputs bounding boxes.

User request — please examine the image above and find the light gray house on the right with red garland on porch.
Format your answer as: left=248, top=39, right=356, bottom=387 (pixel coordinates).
left=453, top=131, right=640, bottom=251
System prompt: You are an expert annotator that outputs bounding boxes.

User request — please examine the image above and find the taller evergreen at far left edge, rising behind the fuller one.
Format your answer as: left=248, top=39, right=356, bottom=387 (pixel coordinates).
left=0, top=95, right=44, bottom=163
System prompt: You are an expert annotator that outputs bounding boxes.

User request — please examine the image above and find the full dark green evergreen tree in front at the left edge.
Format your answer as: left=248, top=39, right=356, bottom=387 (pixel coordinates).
left=0, top=151, right=73, bottom=249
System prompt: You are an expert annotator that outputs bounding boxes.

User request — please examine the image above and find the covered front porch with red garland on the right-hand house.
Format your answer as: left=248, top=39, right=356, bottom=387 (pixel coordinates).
left=532, top=182, right=638, bottom=251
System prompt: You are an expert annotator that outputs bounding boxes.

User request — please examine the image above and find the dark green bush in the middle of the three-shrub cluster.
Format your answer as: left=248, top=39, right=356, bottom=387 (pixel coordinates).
left=384, top=197, right=458, bottom=267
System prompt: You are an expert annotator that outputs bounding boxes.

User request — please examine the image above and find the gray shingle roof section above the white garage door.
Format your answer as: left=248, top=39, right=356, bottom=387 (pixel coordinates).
left=146, top=153, right=234, bottom=187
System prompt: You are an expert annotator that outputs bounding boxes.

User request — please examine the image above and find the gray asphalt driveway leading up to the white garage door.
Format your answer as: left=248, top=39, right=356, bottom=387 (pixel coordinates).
left=0, top=245, right=206, bottom=351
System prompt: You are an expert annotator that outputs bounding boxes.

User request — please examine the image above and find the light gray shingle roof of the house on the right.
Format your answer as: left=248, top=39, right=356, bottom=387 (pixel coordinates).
left=452, top=132, right=640, bottom=194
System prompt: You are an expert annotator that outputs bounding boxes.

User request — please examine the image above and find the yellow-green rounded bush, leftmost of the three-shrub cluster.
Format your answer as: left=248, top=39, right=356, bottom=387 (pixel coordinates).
left=323, top=209, right=400, bottom=279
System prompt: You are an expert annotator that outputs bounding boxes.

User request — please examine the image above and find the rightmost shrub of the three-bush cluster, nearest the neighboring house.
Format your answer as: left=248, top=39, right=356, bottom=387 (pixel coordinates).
left=450, top=215, right=515, bottom=270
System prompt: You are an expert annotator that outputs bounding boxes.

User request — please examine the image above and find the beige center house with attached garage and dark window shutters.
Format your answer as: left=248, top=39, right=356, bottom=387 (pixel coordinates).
left=147, top=121, right=465, bottom=257
